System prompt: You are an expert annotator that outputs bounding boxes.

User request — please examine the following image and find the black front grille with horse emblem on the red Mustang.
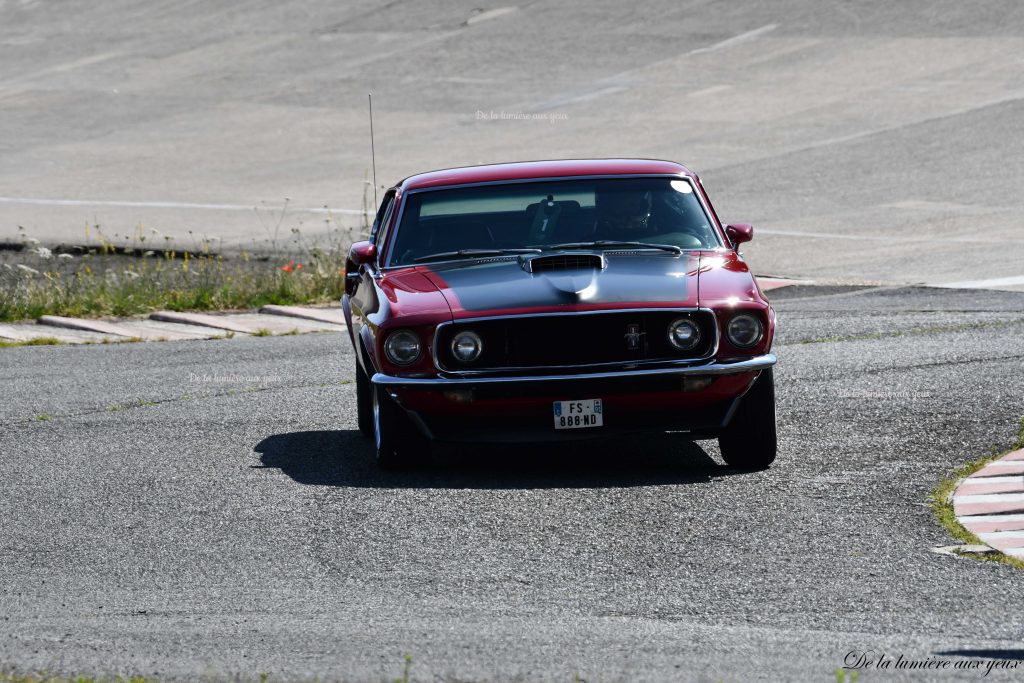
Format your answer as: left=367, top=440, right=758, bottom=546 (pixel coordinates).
left=436, top=310, right=717, bottom=372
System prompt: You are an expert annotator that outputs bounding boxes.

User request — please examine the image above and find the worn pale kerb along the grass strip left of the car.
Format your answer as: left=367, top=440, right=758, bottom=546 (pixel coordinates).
left=0, top=306, right=345, bottom=344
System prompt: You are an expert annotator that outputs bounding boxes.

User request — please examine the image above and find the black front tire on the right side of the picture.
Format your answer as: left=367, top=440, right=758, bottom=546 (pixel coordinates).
left=718, top=368, right=777, bottom=470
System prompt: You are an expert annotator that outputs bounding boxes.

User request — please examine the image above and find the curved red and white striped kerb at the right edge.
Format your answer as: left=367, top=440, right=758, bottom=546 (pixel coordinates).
left=952, top=449, right=1024, bottom=559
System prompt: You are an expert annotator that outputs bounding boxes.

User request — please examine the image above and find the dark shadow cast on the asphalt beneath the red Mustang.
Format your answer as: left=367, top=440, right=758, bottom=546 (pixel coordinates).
left=253, top=430, right=737, bottom=488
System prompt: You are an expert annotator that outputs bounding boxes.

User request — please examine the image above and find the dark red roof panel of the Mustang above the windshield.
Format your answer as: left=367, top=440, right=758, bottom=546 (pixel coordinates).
left=398, top=159, right=693, bottom=191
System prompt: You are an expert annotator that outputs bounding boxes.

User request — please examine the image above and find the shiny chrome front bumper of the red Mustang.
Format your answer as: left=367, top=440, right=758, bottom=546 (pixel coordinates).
left=370, top=353, right=775, bottom=387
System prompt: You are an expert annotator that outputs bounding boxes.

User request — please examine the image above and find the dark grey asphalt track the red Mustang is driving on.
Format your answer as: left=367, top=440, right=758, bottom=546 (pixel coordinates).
left=0, top=287, right=1024, bottom=681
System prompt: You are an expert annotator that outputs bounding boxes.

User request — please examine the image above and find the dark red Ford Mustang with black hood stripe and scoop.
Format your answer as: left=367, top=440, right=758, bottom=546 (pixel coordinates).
left=341, top=159, right=775, bottom=469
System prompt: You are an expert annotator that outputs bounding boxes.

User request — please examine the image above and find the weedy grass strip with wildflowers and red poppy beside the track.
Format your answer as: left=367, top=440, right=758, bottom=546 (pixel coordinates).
left=0, top=205, right=368, bottom=321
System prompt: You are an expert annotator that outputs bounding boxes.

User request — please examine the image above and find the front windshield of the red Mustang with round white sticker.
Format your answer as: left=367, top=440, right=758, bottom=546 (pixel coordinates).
left=388, top=177, right=722, bottom=266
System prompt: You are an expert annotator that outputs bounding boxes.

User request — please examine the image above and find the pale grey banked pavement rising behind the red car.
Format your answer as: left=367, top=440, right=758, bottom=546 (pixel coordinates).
left=0, top=0, right=1024, bottom=290
